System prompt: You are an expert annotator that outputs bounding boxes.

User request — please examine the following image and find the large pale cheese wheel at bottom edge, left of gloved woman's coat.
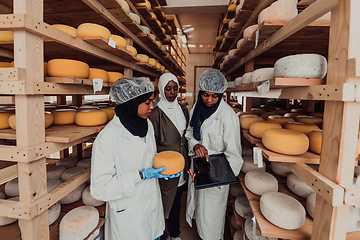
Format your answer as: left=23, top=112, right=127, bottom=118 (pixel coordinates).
left=59, top=206, right=99, bottom=240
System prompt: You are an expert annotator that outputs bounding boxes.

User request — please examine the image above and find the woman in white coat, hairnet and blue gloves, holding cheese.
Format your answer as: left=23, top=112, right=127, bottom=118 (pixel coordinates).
left=90, top=77, right=179, bottom=240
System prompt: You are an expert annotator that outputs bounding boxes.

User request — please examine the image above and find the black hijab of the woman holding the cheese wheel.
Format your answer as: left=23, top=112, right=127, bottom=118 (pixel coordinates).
left=115, top=92, right=155, bottom=137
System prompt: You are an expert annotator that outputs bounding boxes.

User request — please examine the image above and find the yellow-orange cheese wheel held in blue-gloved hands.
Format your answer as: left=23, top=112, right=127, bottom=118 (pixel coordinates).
left=153, top=151, right=185, bottom=175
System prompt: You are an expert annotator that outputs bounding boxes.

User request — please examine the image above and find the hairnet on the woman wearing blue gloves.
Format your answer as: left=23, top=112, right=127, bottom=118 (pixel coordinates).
left=109, top=77, right=154, bottom=104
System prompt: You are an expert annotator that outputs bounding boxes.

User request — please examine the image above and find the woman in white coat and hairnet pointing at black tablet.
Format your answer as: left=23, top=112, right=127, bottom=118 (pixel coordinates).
left=186, top=69, right=243, bottom=240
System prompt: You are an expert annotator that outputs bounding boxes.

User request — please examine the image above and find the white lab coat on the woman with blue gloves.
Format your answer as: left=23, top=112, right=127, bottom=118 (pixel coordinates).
left=90, top=116, right=165, bottom=240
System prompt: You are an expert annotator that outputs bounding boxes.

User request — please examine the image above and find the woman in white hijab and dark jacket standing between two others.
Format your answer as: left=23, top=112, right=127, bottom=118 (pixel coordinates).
left=149, top=73, right=189, bottom=240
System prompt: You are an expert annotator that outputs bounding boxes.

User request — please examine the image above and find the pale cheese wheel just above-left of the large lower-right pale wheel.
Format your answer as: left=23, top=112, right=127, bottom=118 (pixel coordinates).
left=245, top=170, right=279, bottom=196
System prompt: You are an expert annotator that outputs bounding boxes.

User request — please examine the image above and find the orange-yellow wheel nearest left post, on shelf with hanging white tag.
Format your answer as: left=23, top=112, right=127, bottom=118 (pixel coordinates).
left=47, top=59, right=90, bottom=78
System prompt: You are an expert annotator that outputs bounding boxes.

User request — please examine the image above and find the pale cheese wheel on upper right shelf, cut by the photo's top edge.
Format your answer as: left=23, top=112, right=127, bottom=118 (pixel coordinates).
left=258, top=0, right=298, bottom=24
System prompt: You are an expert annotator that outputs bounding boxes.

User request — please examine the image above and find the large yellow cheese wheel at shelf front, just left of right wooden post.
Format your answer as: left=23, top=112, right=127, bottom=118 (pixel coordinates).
left=262, top=128, right=309, bottom=155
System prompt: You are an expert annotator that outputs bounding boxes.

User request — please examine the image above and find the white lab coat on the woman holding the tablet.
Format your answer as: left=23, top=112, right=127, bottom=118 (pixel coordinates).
left=185, top=99, right=243, bottom=240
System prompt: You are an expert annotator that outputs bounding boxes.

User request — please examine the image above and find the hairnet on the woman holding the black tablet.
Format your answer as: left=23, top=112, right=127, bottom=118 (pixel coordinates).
left=199, top=68, right=228, bottom=93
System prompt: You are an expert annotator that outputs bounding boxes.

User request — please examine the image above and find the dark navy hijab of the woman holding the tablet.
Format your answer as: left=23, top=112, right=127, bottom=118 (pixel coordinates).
left=190, top=90, right=223, bottom=141
